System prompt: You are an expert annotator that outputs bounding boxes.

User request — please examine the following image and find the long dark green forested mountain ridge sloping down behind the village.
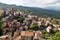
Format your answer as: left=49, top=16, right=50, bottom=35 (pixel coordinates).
left=0, top=3, right=60, bottom=18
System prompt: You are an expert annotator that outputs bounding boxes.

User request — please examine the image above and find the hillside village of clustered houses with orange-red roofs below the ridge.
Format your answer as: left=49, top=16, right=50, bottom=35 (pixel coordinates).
left=0, top=8, right=60, bottom=40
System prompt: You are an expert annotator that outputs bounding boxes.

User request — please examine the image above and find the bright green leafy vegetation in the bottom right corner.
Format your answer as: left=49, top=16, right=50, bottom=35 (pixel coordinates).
left=41, top=30, right=60, bottom=40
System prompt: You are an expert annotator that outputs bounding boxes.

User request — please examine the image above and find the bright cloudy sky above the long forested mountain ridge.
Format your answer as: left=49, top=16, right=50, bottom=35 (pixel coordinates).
left=0, top=0, right=60, bottom=8
